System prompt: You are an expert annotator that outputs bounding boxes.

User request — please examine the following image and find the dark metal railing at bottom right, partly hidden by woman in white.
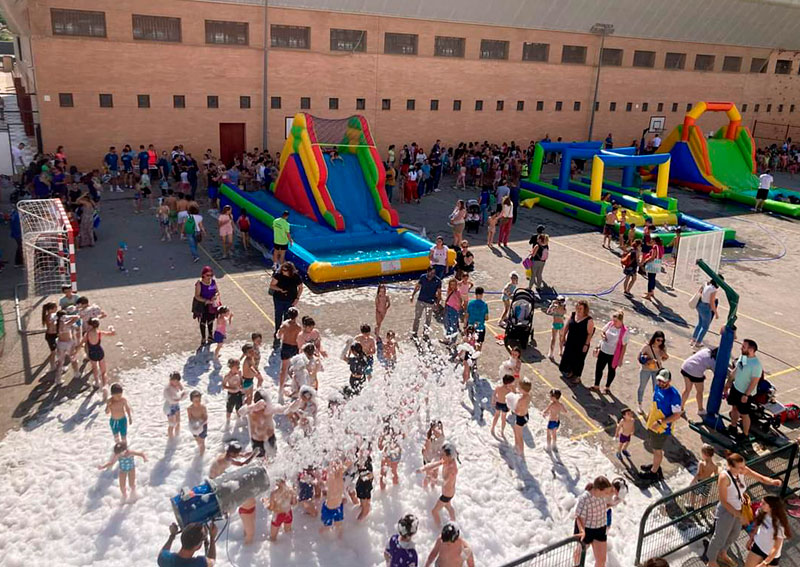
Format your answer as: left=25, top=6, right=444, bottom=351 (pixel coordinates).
left=636, top=443, right=800, bottom=565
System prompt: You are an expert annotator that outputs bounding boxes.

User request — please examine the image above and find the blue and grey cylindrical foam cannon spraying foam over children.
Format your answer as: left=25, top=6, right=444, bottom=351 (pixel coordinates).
left=171, top=464, right=270, bottom=529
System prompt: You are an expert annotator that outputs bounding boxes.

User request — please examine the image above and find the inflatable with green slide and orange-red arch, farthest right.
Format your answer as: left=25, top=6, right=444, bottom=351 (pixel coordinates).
left=657, top=102, right=800, bottom=217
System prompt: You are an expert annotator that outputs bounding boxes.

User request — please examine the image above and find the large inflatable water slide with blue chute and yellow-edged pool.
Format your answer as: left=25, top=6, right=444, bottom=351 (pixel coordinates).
left=220, top=113, right=455, bottom=283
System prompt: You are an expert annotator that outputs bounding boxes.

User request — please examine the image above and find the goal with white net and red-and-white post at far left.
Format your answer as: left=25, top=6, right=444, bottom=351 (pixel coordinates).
left=17, top=199, right=77, bottom=297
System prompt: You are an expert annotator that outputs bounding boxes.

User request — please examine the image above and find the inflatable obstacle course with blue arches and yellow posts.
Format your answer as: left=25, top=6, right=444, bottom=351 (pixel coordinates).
left=520, top=142, right=738, bottom=246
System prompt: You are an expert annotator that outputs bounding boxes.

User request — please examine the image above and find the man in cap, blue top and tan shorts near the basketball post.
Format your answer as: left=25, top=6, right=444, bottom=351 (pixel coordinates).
left=642, top=368, right=682, bottom=480
